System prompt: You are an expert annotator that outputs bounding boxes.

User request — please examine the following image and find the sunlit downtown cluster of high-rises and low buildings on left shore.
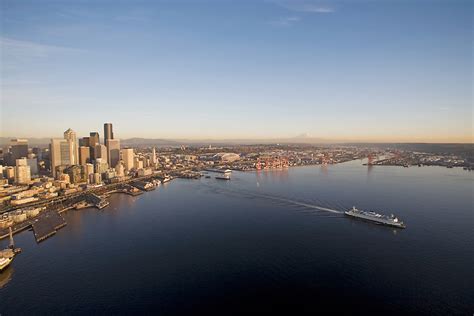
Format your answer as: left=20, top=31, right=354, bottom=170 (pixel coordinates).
left=0, top=123, right=157, bottom=209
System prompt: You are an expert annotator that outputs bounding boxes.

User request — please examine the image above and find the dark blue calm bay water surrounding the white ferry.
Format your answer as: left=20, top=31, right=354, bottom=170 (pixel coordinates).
left=0, top=161, right=474, bottom=315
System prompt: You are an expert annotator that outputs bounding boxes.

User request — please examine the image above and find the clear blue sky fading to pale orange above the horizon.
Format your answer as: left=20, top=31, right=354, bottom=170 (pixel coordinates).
left=0, top=0, right=474, bottom=142
